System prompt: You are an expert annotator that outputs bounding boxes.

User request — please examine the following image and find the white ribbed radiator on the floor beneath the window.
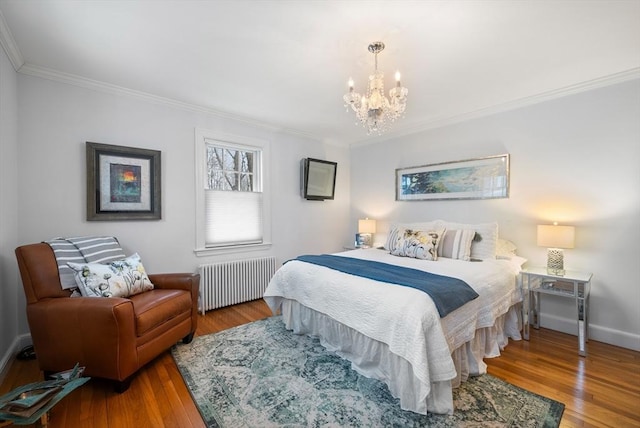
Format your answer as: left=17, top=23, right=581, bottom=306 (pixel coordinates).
left=198, top=257, right=277, bottom=314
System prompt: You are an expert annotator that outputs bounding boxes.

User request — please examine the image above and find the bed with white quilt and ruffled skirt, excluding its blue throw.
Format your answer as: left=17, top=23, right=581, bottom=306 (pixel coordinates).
left=264, top=221, right=524, bottom=414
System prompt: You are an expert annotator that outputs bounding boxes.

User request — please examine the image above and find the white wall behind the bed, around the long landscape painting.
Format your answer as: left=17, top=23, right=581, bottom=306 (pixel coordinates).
left=350, top=80, right=640, bottom=350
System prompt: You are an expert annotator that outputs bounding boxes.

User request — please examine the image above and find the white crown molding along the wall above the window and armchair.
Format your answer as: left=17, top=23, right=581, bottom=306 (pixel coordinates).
left=17, top=63, right=320, bottom=141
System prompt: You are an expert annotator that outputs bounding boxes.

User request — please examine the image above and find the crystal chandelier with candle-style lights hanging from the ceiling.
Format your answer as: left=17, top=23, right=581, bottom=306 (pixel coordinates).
left=343, top=42, right=409, bottom=135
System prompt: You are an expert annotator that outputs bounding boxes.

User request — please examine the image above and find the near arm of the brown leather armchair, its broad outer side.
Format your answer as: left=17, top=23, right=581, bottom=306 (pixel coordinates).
left=27, top=297, right=138, bottom=380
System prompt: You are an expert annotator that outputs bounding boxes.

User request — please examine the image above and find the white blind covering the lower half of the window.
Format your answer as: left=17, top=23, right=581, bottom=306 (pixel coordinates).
left=205, top=190, right=263, bottom=246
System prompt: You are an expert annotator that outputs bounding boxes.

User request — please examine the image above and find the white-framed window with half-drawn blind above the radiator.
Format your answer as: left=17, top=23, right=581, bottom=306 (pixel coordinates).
left=196, top=130, right=269, bottom=253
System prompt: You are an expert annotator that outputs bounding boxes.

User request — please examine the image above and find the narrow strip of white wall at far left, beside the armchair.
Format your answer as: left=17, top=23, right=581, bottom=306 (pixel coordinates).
left=0, top=35, right=24, bottom=373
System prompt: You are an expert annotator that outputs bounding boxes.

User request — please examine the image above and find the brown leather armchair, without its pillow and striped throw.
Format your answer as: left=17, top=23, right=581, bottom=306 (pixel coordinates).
left=16, top=243, right=200, bottom=392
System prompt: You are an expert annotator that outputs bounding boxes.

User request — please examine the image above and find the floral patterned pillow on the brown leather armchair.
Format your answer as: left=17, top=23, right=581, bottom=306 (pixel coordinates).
left=67, top=253, right=153, bottom=297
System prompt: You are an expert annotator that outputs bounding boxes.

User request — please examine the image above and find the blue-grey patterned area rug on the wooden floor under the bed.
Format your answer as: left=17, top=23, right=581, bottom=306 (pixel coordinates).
left=171, top=316, right=564, bottom=428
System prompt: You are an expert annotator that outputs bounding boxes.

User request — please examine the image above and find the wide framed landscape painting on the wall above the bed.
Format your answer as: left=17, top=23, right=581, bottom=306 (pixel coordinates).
left=396, top=154, right=509, bottom=201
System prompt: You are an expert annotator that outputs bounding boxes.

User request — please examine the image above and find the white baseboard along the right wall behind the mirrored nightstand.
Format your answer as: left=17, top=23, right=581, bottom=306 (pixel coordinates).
left=540, top=312, right=640, bottom=351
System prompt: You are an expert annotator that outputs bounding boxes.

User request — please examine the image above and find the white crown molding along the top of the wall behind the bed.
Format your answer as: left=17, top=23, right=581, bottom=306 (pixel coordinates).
left=349, top=67, right=640, bottom=147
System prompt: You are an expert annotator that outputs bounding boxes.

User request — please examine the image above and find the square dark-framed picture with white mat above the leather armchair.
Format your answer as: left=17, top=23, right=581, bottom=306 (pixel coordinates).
left=86, top=142, right=162, bottom=221
